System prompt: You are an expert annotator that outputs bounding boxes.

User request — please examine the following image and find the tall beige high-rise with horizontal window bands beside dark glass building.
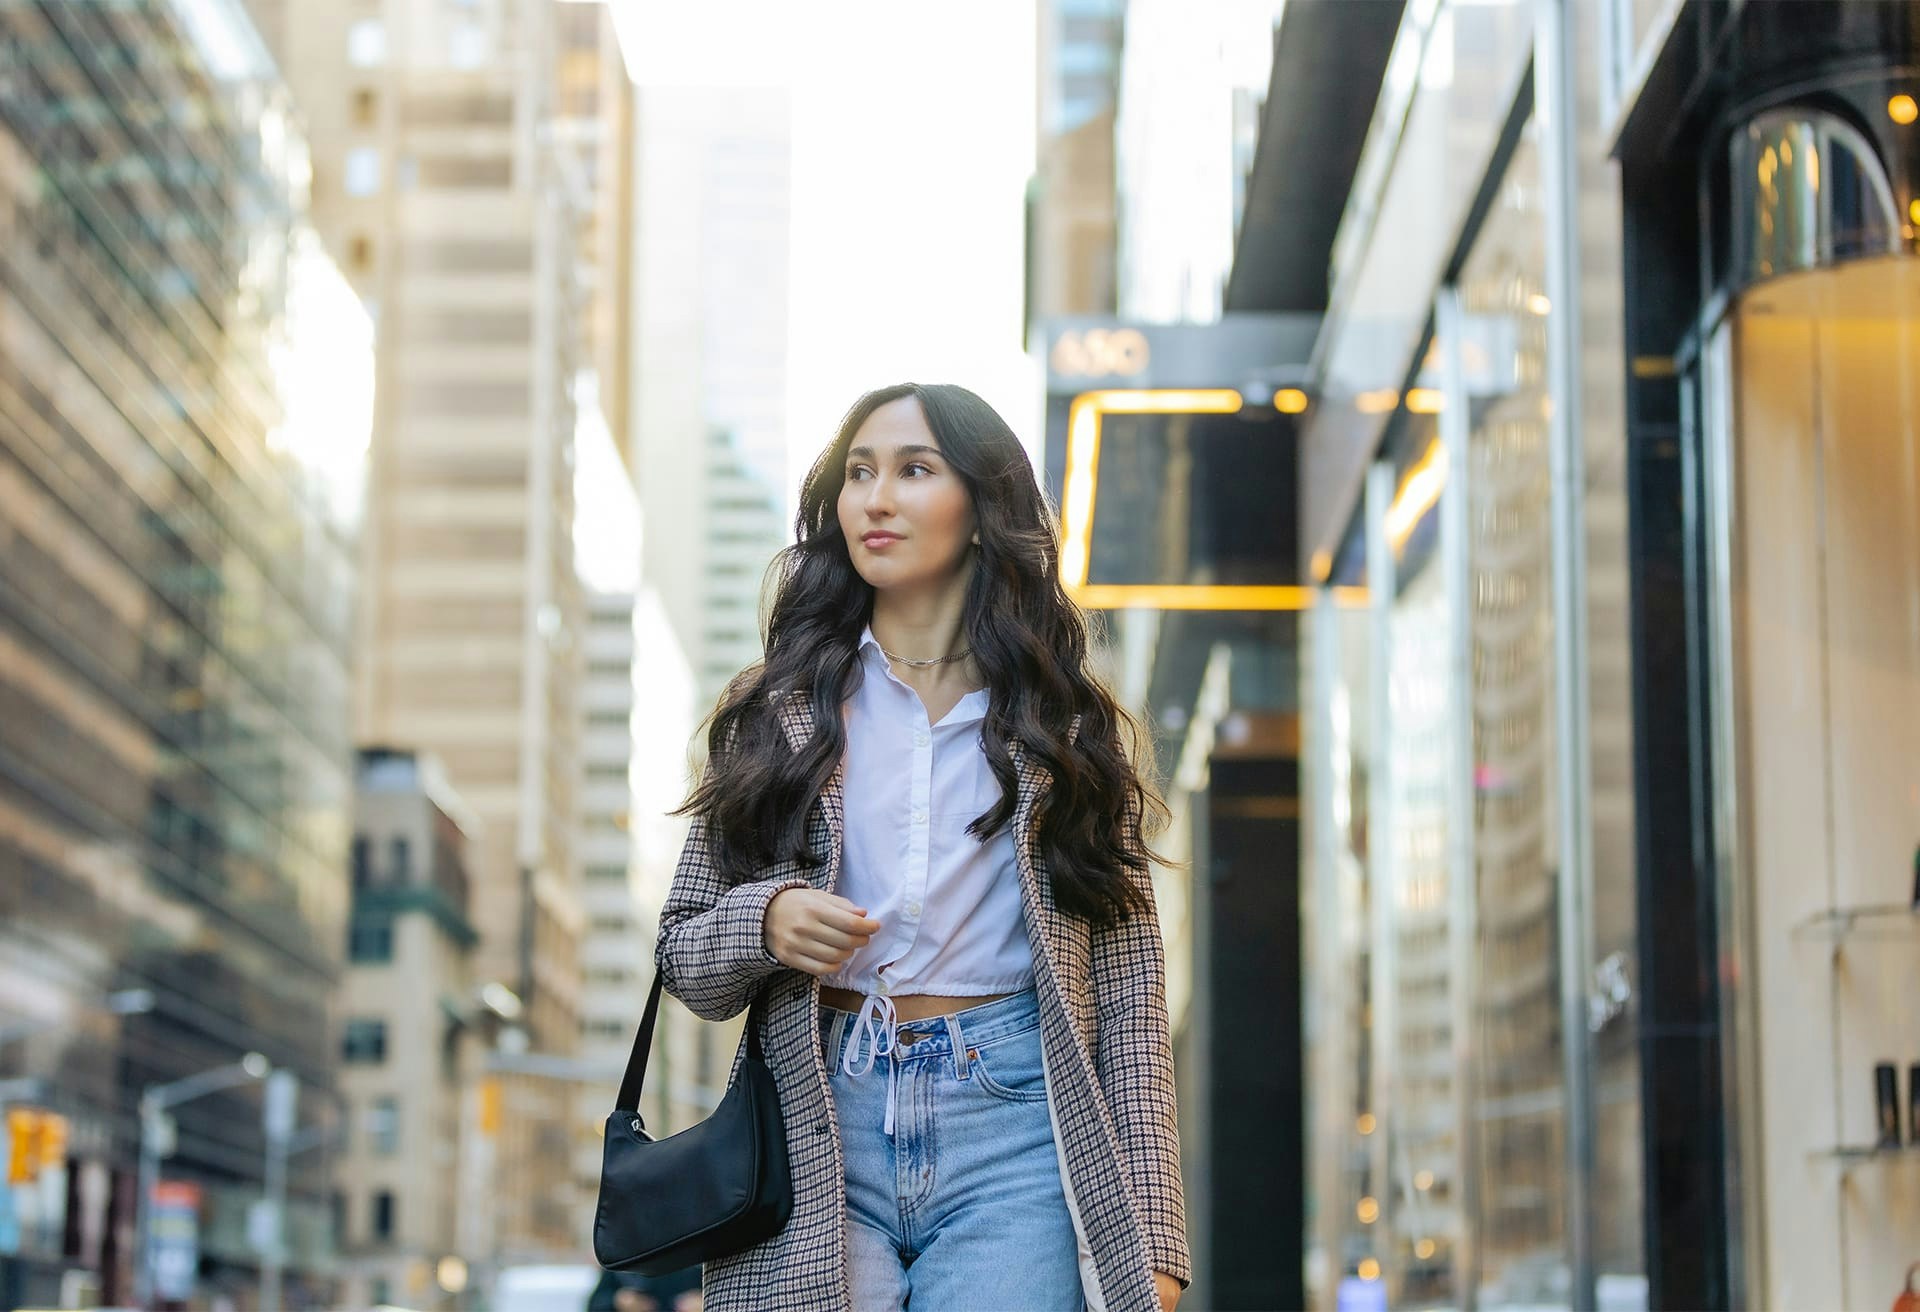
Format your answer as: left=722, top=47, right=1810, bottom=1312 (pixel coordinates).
left=251, top=0, right=593, bottom=1260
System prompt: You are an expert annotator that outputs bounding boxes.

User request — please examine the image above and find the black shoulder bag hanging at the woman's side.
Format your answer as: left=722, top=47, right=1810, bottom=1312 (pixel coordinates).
left=593, top=972, right=793, bottom=1276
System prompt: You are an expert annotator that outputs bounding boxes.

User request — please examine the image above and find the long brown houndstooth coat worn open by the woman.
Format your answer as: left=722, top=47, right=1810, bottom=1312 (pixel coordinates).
left=655, top=697, right=1190, bottom=1312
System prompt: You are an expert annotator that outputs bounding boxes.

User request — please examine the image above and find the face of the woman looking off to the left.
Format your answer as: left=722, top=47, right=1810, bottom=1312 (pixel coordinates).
left=839, top=396, right=973, bottom=592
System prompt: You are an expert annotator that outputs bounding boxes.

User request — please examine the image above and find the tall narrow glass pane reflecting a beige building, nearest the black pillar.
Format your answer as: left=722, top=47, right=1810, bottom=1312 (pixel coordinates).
left=1457, top=125, right=1584, bottom=1308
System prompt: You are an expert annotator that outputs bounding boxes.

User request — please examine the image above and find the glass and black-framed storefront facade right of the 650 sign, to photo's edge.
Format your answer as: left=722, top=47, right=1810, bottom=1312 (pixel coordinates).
left=1302, top=0, right=1920, bottom=1308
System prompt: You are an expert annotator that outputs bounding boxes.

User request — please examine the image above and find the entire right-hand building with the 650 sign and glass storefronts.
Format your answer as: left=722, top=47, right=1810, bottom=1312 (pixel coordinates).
left=1033, top=0, right=1920, bottom=1308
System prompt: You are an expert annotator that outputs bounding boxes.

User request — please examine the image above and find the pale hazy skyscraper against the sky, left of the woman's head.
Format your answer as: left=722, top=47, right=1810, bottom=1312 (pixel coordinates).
left=616, top=86, right=793, bottom=707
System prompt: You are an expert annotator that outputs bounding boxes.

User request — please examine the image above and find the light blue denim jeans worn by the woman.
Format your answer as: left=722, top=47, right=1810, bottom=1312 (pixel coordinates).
left=820, top=989, right=1083, bottom=1312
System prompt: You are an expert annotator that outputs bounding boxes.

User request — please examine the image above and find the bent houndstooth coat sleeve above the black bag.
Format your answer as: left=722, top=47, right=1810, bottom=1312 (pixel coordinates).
left=653, top=816, right=806, bottom=1020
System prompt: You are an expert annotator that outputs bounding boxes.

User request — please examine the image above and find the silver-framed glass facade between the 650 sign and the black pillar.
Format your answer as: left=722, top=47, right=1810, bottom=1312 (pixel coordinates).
left=1304, top=4, right=1647, bottom=1308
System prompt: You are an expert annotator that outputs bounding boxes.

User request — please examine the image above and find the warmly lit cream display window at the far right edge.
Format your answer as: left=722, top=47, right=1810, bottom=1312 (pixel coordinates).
left=1703, top=257, right=1920, bottom=1306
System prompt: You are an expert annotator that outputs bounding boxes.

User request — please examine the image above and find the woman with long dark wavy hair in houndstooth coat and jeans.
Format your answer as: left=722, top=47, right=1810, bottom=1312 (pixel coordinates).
left=655, top=384, right=1188, bottom=1312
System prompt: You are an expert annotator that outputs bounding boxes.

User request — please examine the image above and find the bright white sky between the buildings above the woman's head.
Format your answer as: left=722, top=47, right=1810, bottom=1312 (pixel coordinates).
left=612, top=0, right=1041, bottom=498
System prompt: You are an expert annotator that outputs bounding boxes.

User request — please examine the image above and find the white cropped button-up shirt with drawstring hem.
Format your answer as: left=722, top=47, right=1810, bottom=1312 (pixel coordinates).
left=826, top=628, right=1033, bottom=997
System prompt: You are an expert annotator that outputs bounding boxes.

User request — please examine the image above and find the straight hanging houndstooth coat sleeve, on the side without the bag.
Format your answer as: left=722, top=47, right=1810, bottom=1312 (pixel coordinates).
left=1092, top=795, right=1192, bottom=1285
